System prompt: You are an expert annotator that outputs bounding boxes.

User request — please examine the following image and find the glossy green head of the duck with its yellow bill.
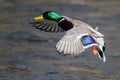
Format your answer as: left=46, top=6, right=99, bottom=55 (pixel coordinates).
left=34, top=11, right=62, bottom=22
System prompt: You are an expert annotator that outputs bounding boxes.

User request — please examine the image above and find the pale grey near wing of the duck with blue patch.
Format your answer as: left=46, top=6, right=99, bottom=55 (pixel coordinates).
left=56, top=27, right=97, bottom=55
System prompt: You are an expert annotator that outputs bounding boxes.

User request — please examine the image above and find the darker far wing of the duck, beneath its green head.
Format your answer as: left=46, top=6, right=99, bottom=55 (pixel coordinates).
left=30, top=20, right=64, bottom=32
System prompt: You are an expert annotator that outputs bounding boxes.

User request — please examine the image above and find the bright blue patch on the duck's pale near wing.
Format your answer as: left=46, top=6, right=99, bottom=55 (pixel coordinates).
left=81, top=35, right=96, bottom=45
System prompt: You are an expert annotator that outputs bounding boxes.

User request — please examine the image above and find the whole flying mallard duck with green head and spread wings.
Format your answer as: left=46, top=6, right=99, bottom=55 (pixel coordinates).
left=31, top=11, right=106, bottom=62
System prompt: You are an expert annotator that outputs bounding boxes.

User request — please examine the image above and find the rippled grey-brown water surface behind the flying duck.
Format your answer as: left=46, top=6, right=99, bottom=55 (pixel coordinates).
left=0, top=0, right=120, bottom=80
